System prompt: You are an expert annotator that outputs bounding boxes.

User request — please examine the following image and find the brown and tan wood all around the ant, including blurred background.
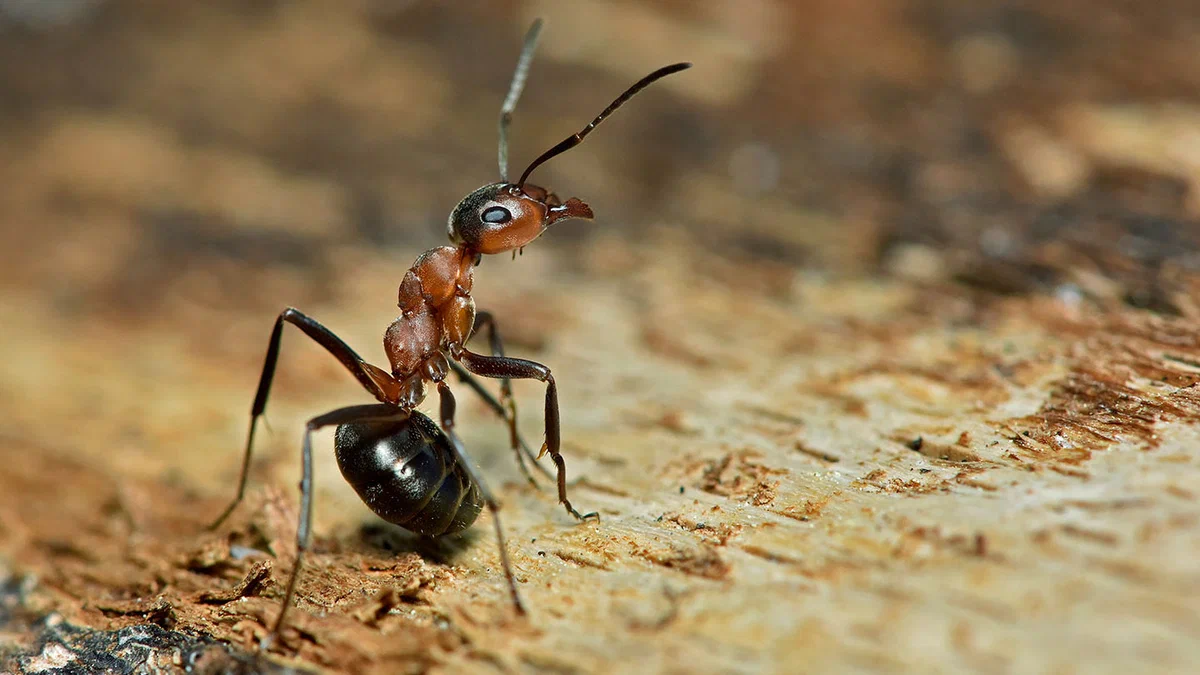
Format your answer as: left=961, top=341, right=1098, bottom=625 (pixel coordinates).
left=0, top=1, right=1200, bottom=673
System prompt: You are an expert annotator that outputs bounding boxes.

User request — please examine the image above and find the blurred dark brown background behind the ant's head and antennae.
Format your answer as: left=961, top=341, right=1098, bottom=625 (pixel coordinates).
left=0, top=0, right=1200, bottom=321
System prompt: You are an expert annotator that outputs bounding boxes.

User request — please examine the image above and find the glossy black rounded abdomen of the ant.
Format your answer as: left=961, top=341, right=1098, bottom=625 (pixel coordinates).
left=334, top=412, right=484, bottom=537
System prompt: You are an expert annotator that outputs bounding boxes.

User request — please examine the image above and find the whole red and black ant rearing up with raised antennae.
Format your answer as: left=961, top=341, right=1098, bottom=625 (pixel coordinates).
left=209, top=19, right=691, bottom=635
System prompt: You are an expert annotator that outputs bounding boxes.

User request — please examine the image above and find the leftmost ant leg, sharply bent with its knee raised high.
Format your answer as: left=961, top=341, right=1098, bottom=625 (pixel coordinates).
left=209, top=307, right=400, bottom=530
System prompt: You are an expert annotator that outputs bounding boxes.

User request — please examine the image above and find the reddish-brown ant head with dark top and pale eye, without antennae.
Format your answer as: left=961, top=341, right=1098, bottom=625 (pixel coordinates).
left=446, top=183, right=592, bottom=253
